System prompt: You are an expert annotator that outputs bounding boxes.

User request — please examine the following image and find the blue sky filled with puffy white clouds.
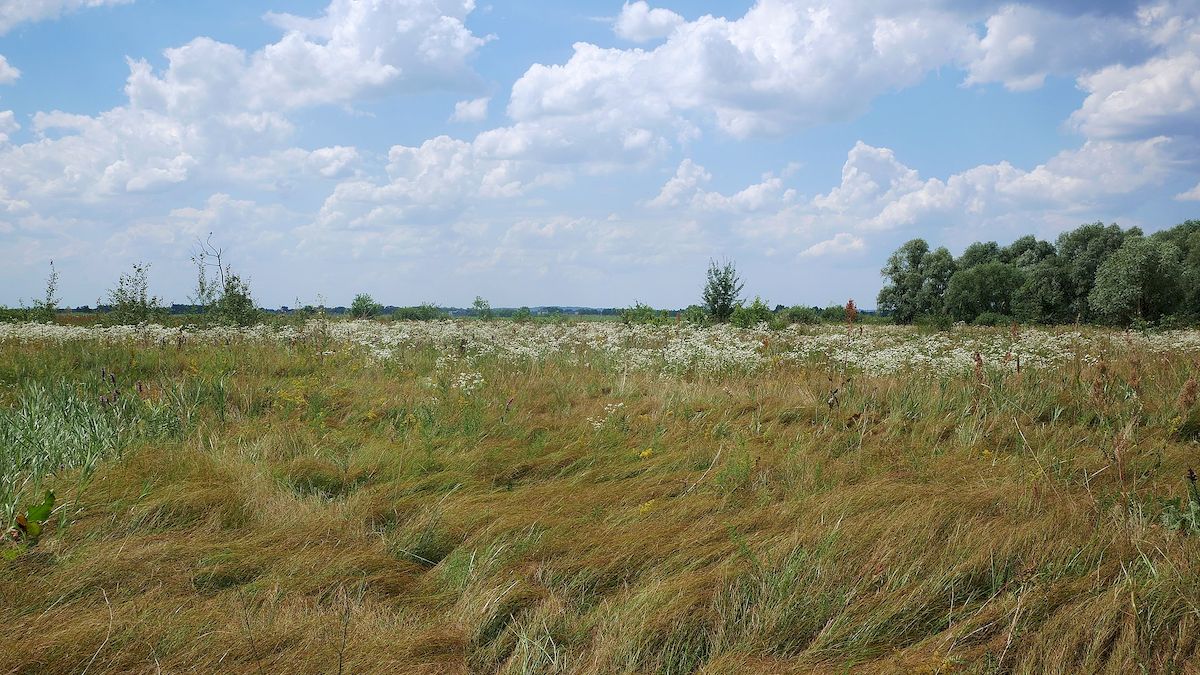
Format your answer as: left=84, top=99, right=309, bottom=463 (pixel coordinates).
left=0, top=0, right=1200, bottom=307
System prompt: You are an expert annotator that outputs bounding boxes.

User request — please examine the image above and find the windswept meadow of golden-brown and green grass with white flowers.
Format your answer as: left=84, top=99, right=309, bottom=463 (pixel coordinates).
left=0, top=321, right=1200, bottom=674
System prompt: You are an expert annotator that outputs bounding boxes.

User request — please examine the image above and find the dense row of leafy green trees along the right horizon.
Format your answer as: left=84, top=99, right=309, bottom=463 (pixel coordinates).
left=877, top=220, right=1200, bottom=327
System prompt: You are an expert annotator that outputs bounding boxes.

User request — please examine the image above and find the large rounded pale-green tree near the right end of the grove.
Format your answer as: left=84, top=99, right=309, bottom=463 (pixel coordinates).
left=1087, top=237, right=1183, bottom=324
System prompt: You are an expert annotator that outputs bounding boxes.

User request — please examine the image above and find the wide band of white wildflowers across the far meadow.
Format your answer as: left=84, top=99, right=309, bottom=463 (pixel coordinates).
left=0, top=319, right=1200, bottom=379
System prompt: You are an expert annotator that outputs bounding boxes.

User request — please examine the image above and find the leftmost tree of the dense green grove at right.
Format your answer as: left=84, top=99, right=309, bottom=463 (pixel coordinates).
left=876, top=239, right=955, bottom=323
